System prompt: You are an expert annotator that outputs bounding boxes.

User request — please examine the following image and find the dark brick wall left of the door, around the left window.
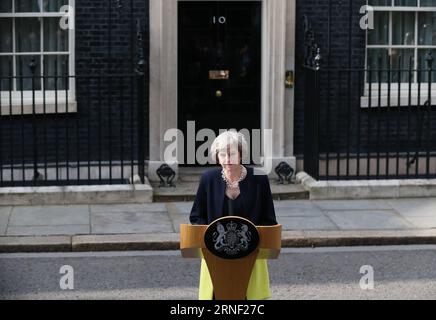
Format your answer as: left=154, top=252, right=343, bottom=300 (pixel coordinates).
left=0, top=0, right=149, bottom=169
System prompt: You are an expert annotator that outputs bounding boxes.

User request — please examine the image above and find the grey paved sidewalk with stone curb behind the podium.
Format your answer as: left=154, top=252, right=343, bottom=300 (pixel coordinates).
left=0, top=198, right=436, bottom=252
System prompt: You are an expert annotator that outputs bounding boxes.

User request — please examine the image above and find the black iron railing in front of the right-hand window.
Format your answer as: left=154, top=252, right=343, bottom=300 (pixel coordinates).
left=302, top=9, right=436, bottom=180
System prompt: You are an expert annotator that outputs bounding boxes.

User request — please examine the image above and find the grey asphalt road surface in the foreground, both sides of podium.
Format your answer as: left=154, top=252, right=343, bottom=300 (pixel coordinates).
left=0, top=246, right=436, bottom=300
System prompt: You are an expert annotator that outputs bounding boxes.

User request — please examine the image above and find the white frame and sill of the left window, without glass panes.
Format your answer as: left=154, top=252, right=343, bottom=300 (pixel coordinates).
left=0, top=0, right=77, bottom=116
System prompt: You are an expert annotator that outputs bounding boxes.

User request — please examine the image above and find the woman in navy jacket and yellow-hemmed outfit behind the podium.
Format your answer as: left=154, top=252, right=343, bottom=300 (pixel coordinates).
left=190, top=131, right=277, bottom=300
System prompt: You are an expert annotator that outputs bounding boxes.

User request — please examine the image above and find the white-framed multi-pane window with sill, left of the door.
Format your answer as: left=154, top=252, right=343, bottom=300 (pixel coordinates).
left=0, top=0, right=75, bottom=115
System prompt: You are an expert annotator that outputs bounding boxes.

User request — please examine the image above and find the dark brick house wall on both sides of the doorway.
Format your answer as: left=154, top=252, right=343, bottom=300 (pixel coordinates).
left=0, top=0, right=436, bottom=172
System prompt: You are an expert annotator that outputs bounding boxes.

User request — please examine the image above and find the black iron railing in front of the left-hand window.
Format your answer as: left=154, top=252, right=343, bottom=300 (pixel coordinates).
left=0, top=73, right=146, bottom=186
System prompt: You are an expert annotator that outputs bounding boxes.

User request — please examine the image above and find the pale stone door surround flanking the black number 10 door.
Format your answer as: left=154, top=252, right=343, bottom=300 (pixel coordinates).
left=148, top=0, right=296, bottom=181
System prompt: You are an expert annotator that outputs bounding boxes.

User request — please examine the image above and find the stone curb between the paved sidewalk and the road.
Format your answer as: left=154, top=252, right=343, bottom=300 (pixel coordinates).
left=0, top=229, right=436, bottom=253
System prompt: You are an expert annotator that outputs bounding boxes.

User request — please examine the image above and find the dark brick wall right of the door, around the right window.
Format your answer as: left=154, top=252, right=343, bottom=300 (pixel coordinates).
left=294, top=0, right=436, bottom=157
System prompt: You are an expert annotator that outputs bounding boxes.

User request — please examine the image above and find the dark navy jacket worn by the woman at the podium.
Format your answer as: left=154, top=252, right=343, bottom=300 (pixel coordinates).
left=190, top=168, right=277, bottom=226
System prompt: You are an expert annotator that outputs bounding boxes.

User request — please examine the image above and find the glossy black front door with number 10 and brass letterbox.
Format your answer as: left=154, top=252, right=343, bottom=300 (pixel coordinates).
left=178, top=1, right=262, bottom=164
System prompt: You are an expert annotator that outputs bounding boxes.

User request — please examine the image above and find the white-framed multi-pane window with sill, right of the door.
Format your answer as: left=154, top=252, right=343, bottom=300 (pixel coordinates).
left=365, top=0, right=436, bottom=105
